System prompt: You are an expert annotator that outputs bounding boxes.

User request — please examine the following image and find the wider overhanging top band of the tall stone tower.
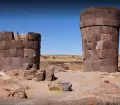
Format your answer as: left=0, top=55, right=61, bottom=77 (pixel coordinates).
left=80, top=7, right=120, bottom=28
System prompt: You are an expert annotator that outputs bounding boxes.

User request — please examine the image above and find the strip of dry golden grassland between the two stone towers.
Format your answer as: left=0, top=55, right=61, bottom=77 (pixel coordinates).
left=40, top=55, right=83, bottom=70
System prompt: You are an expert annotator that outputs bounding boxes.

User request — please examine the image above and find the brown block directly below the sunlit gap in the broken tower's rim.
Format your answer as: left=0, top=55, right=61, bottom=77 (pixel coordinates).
left=10, top=40, right=23, bottom=49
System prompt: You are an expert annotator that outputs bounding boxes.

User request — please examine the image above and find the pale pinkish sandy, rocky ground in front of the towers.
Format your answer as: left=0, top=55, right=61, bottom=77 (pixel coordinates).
left=0, top=70, right=120, bottom=105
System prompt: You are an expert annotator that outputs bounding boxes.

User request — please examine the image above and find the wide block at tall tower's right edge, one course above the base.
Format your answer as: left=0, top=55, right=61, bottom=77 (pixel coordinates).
left=98, top=58, right=118, bottom=66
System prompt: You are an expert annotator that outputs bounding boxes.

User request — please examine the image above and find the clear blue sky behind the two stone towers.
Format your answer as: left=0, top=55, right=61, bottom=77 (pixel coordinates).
left=0, top=4, right=119, bottom=55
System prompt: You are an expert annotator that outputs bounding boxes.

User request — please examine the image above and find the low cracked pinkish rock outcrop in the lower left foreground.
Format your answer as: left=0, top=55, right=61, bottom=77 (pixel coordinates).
left=0, top=80, right=29, bottom=98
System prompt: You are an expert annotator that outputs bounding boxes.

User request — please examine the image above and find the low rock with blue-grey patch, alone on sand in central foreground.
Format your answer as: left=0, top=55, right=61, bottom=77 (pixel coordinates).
left=48, top=82, right=72, bottom=91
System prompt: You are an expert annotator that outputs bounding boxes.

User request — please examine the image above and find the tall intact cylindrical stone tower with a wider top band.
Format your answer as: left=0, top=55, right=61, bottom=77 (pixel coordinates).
left=80, top=7, right=120, bottom=72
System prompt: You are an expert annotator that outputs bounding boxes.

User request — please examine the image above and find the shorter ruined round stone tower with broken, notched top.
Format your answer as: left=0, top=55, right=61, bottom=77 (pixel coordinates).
left=0, top=31, right=41, bottom=70
